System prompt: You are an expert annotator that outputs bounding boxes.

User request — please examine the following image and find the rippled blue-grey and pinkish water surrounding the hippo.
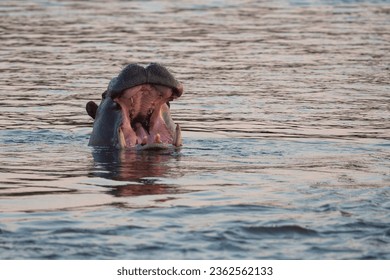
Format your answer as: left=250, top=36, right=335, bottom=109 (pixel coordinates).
left=0, top=0, right=390, bottom=259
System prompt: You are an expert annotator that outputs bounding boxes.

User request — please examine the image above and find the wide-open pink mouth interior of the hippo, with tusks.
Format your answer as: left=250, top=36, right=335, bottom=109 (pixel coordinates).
left=114, top=84, right=182, bottom=149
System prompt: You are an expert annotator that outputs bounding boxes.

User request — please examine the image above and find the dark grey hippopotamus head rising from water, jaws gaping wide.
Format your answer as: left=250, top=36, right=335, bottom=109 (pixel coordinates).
left=86, top=63, right=183, bottom=149
